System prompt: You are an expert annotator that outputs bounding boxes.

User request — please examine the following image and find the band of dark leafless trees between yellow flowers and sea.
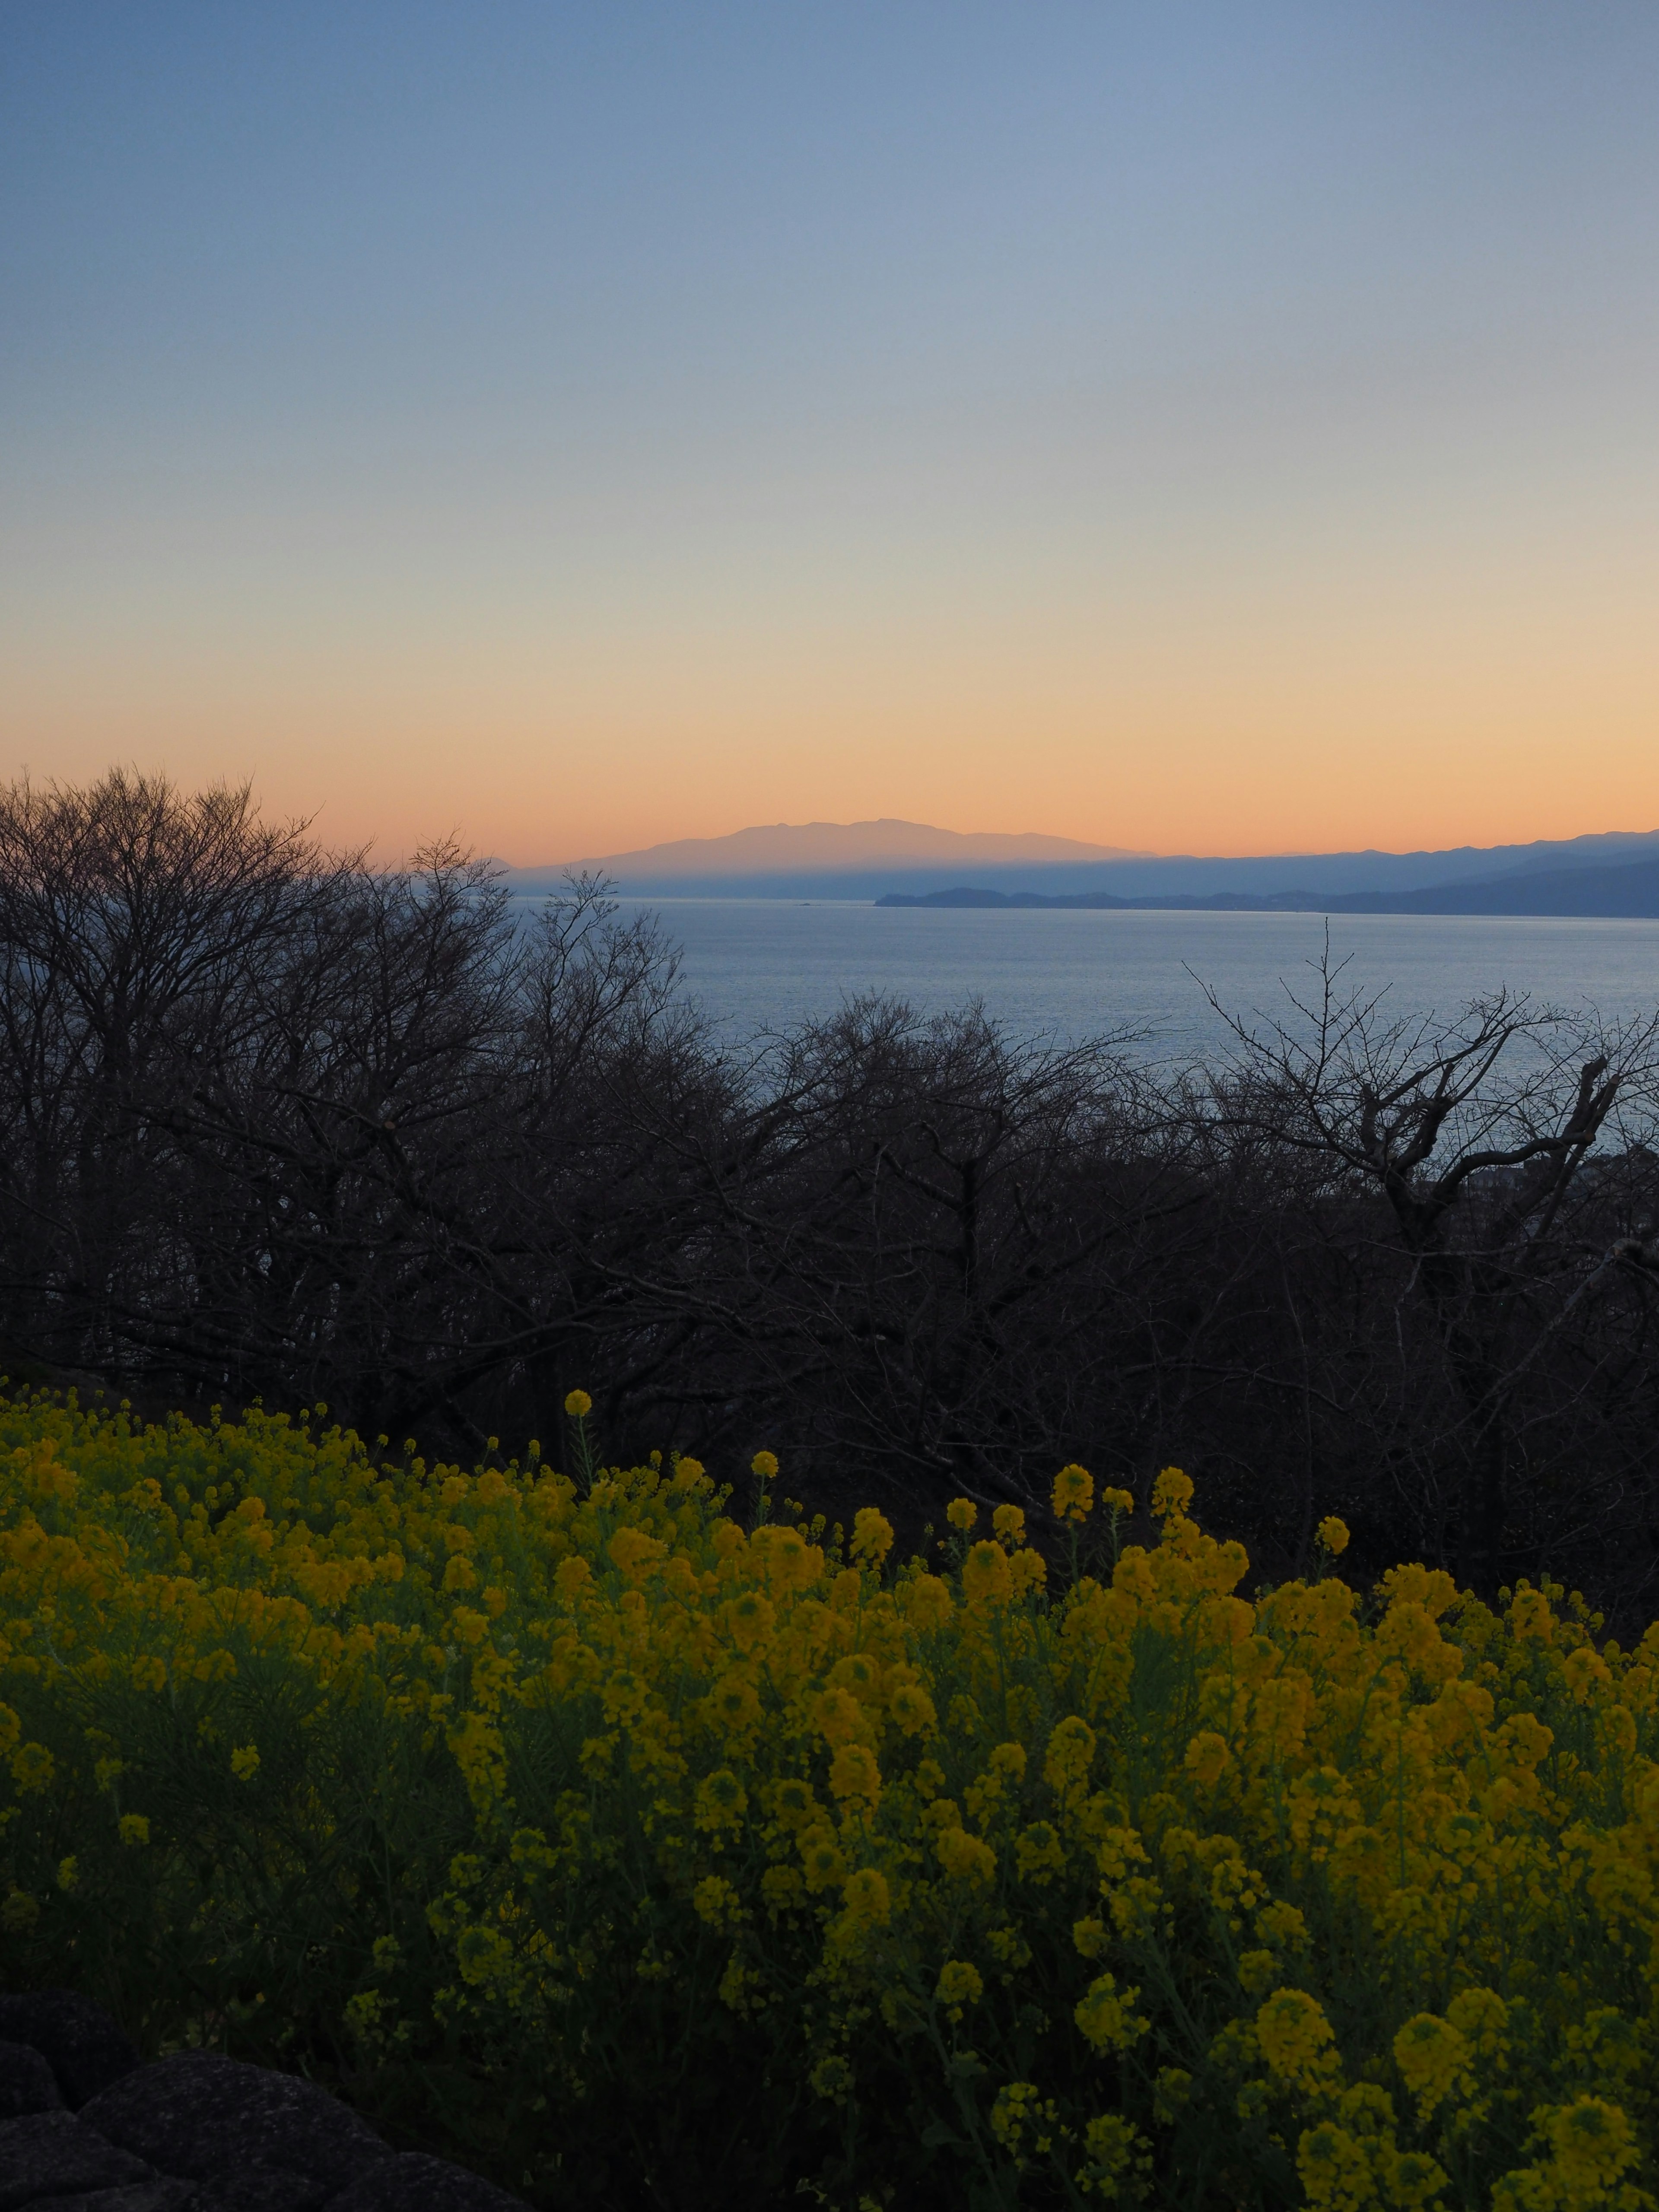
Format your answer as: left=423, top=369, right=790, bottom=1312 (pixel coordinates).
left=0, top=772, right=1659, bottom=1604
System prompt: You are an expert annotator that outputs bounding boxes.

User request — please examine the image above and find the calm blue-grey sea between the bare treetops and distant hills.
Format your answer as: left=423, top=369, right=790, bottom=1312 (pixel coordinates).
left=606, top=898, right=1659, bottom=1059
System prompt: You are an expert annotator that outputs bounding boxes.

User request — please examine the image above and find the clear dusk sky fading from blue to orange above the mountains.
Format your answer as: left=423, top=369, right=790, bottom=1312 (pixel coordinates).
left=0, top=0, right=1659, bottom=863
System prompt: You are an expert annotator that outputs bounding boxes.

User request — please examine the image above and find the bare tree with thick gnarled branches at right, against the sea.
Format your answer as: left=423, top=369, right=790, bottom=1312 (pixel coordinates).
left=1212, top=951, right=1659, bottom=1590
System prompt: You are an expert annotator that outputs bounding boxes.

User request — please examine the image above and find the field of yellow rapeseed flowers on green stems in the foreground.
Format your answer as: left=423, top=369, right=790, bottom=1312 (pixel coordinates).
left=0, top=1396, right=1659, bottom=2212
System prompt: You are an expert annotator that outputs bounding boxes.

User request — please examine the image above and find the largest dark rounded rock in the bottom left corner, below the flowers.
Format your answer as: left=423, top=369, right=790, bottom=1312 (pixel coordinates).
left=81, top=2050, right=391, bottom=2212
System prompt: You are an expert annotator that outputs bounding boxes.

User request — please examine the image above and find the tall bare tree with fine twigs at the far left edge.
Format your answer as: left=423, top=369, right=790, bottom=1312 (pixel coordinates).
left=0, top=770, right=325, bottom=1374
